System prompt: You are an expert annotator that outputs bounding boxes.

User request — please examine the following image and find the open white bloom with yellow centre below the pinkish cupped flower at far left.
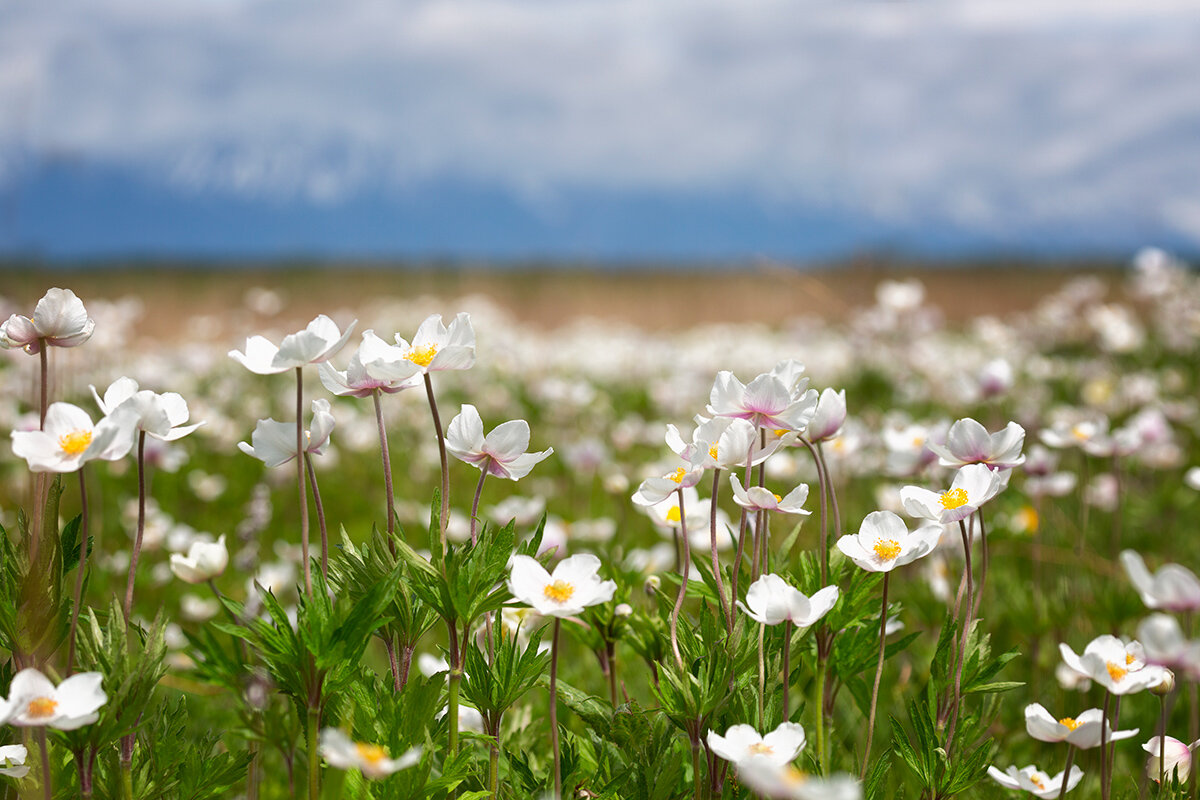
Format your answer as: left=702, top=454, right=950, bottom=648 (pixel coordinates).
left=12, top=403, right=137, bottom=473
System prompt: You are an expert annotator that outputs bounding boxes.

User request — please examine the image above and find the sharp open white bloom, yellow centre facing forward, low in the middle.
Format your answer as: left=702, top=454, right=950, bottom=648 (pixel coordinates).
left=508, top=553, right=617, bottom=616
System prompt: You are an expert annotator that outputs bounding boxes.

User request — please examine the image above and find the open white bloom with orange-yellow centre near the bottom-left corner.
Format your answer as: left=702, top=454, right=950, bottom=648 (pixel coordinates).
left=0, top=667, right=108, bottom=730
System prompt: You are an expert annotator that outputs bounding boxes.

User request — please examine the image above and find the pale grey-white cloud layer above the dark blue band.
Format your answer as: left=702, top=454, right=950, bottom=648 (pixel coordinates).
left=0, top=0, right=1200, bottom=241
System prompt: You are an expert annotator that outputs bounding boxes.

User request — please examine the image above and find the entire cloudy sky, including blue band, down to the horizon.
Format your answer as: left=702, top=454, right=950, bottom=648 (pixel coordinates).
left=0, top=0, right=1200, bottom=261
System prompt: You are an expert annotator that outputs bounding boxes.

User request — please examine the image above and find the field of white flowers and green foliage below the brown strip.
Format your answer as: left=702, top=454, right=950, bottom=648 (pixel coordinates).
left=0, top=251, right=1200, bottom=800
